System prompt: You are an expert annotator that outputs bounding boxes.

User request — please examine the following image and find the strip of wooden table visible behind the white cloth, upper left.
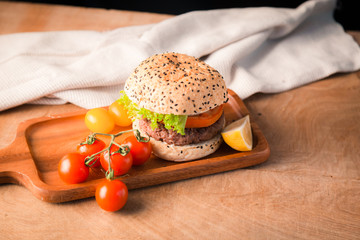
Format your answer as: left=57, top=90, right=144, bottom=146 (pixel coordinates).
left=0, top=1, right=171, bottom=34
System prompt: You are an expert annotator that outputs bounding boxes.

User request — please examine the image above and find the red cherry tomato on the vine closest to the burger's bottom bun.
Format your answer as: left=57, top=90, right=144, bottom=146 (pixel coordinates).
left=123, top=135, right=152, bottom=166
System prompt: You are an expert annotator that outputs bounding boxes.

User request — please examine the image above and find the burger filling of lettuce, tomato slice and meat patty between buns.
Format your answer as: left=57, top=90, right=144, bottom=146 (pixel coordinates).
left=118, top=91, right=225, bottom=142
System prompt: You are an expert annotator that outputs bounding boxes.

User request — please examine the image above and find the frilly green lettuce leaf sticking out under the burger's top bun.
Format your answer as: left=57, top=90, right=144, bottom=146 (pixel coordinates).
left=117, top=91, right=187, bottom=135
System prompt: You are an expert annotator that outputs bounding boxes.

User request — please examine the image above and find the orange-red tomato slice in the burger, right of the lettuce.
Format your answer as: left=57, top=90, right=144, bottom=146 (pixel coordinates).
left=185, top=105, right=224, bottom=128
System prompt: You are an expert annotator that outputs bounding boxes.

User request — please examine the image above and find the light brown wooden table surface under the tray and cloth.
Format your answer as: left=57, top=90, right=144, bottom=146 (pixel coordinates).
left=0, top=2, right=360, bottom=239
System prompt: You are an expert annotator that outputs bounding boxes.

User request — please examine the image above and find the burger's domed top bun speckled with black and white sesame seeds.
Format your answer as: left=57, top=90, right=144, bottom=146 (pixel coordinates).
left=124, top=53, right=228, bottom=115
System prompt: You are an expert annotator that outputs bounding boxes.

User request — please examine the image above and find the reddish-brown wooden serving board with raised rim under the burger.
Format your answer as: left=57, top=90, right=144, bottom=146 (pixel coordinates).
left=0, top=90, right=270, bottom=202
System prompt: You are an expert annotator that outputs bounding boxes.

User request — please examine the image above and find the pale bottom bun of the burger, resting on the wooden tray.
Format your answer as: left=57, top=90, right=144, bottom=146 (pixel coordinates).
left=133, top=120, right=222, bottom=162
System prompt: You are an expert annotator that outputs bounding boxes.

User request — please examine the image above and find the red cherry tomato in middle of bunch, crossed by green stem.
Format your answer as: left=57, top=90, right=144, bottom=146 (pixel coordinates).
left=100, top=145, right=133, bottom=176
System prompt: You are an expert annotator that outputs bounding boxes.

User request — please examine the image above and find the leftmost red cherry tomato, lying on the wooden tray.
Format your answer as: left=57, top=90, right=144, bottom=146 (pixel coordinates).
left=58, top=153, right=89, bottom=184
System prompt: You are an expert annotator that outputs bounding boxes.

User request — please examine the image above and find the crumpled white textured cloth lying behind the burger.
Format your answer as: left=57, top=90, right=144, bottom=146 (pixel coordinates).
left=0, top=0, right=360, bottom=111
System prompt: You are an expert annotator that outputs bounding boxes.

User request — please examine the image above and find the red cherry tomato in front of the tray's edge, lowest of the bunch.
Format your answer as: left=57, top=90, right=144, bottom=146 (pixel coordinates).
left=95, top=180, right=128, bottom=212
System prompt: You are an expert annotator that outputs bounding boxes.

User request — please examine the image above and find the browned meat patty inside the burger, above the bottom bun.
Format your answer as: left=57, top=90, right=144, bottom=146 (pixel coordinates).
left=139, top=114, right=225, bottom=146
